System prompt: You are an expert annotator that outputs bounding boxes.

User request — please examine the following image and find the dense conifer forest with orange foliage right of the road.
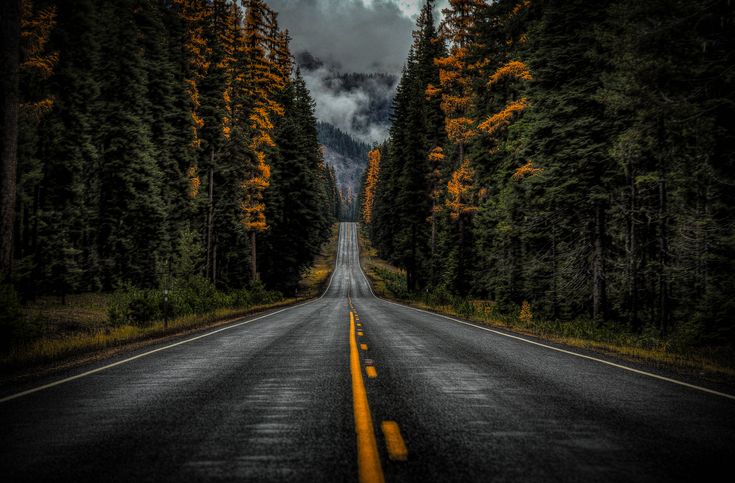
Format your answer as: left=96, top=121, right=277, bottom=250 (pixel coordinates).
left=362, top=0, right=735, bottom=342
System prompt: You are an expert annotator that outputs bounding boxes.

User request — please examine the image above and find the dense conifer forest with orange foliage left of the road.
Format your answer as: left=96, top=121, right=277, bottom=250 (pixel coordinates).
left=0, top=0, right=339, bottom=298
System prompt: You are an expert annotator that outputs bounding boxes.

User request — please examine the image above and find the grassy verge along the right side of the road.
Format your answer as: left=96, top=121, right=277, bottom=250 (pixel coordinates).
left=359, top=230, right=735, bottom=379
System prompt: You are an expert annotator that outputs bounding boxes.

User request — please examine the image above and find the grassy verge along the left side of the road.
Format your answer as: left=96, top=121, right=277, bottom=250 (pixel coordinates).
left=0, top=225, right=338, bottom=376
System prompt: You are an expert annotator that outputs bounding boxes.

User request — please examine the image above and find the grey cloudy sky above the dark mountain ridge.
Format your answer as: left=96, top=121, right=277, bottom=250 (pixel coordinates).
left=268, top=0, right=420, bottom=73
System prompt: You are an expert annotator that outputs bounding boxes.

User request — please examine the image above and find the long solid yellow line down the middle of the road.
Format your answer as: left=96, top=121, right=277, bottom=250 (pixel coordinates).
left=350, top=312, right=385, bottom=483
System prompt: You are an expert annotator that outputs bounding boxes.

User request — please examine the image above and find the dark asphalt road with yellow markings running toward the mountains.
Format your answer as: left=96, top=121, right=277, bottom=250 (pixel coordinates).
left=0, top=223, right=735, bottom=482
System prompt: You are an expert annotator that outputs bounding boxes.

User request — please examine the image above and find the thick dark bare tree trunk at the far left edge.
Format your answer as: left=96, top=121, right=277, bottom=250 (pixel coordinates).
left=0, top=0, right=20, bottom=281
